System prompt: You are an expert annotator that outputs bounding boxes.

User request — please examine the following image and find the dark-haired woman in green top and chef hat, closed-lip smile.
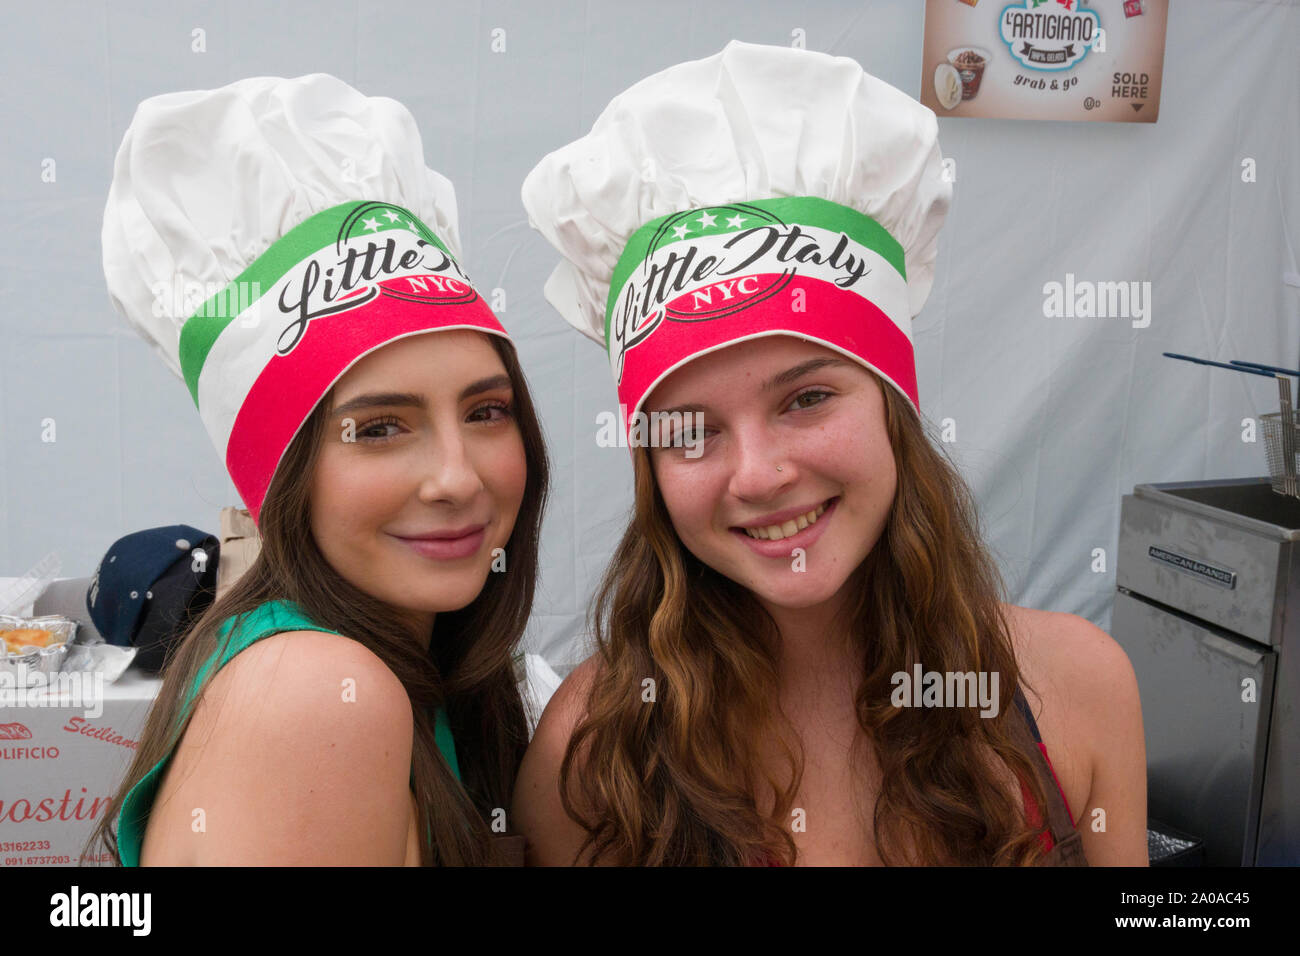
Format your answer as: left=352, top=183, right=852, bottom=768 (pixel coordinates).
left=81, top=74, right=547, bottom=865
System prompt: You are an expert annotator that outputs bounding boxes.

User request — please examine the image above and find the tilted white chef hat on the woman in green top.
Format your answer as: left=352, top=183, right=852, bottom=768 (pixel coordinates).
left=103, top=73, right=507, bottom=522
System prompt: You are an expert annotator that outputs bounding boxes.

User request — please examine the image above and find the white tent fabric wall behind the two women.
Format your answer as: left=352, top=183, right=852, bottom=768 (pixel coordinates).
left=0, top=0, right=1300, bottom=674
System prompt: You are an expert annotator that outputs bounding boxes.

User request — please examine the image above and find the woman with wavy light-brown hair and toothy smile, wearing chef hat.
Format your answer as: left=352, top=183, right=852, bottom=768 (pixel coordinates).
left=515, top=43, right=1145, bottom=865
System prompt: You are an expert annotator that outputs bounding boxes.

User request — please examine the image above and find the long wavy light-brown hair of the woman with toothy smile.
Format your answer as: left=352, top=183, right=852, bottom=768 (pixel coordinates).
left=560, top=377, right=1047, bottom=865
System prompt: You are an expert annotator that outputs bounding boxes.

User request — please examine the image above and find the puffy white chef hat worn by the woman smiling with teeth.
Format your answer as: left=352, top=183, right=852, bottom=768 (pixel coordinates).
left=523, top=40, right=952, bottom=437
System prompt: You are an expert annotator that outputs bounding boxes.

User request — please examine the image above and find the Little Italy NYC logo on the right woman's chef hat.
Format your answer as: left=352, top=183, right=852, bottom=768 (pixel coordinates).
left=606, top=203, right=871, bottom=382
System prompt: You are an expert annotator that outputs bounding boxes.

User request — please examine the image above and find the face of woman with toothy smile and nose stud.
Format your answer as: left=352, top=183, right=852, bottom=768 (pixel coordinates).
left=644, top=336, right=897, bottom=609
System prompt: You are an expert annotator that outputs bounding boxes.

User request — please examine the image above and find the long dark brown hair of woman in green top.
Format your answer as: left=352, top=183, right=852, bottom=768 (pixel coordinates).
left=86, top=336, right=549, bottom=865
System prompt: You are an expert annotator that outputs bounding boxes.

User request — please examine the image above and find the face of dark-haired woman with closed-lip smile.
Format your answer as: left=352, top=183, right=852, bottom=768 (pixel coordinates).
left=311, top=329, right=528, bottom=627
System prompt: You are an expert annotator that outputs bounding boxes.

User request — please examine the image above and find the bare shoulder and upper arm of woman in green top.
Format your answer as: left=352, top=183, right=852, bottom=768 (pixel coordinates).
left=167, top=631, right=413, bottom=865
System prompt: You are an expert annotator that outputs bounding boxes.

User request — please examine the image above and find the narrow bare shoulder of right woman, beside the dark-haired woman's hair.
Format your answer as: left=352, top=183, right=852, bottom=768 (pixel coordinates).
left=512, top=656, right=599, bottom=866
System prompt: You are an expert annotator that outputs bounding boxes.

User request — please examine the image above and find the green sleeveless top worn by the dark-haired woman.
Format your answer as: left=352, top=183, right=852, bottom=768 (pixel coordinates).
left=117, top=601, right=460, bottom=866
